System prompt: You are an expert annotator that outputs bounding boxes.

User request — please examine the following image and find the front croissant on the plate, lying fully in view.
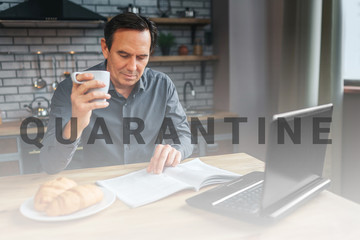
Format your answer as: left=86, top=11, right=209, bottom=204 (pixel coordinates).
left=45, top=184, right=104, bottom=216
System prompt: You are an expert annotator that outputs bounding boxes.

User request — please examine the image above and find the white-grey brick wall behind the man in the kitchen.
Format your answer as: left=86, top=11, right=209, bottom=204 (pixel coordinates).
left=0, top=0, right=213, bottom=121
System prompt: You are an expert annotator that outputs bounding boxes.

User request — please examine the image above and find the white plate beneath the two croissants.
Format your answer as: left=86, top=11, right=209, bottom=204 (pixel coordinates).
left=20, top=188, right=116, bottom=222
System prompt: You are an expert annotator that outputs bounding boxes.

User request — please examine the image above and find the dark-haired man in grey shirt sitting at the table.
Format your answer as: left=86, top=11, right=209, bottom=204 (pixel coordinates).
left=40, top=13, right=192, bottom=173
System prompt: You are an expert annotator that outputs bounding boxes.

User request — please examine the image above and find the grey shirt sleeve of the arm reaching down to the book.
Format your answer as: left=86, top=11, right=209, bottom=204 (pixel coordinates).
left=165, top=77, right=194, bottom=160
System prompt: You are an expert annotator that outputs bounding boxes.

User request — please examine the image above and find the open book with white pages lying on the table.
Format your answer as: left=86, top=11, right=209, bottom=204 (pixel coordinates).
left=96, top=158, right=240, bottom=208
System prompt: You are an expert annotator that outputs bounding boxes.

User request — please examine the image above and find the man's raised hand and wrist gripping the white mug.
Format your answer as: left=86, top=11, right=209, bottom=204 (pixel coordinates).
left=63, top=73, right=110, bottom=139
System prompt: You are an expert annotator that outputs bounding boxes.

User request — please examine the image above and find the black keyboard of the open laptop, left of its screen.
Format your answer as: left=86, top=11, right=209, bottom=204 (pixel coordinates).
left=212, top=181, right=263, bottom=214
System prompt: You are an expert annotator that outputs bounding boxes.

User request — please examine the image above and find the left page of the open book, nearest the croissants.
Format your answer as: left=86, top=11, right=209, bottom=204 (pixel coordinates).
left=96, top=169, right=193, bottom=208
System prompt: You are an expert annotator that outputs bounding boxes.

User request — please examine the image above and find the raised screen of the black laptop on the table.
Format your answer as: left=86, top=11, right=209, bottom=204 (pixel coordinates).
left=262, top=104, right=333, bottom=209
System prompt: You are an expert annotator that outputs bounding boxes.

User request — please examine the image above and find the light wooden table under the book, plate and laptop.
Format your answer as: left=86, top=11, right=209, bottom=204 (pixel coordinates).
left=0, top=153, right=360, bottom=240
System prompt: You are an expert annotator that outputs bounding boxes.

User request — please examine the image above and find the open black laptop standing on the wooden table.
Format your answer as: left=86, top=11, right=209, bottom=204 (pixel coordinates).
left=186, top=104, right=333, bottom=222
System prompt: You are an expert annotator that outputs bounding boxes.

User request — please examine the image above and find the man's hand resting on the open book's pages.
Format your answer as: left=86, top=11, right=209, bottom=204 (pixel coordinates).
left=147, top=144, right=181, bottom=174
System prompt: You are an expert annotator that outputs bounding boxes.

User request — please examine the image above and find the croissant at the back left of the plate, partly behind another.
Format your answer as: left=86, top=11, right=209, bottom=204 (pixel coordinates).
left=34, top=177, right=77, bottom=212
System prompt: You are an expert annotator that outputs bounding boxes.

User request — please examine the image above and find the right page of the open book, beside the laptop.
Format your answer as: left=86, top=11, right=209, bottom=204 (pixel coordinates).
left=164, top=158, right=240, bottom=191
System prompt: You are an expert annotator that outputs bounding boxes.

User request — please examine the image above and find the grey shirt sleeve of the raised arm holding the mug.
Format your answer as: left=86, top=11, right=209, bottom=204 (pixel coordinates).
left=40, top=80, right=80, bottom=174
